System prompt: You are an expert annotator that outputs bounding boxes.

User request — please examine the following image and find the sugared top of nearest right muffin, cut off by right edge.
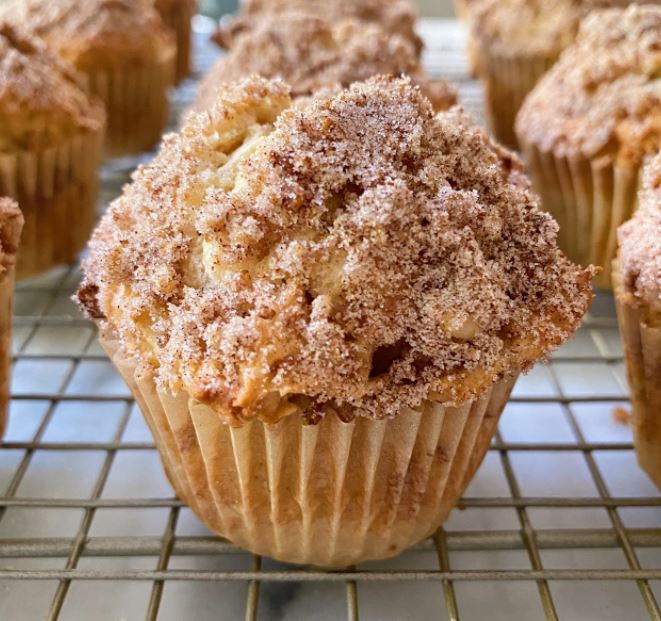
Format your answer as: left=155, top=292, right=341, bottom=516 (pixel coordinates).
left=619, top=154, right=661, bottom=325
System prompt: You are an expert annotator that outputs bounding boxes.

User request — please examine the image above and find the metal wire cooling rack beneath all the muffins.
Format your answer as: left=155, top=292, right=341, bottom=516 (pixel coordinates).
left=0, top=20, right=661, bottom=621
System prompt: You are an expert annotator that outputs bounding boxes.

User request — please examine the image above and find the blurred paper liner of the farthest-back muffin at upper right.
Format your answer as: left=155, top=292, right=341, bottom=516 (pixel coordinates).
left=476, top=49, right=557, bottom=148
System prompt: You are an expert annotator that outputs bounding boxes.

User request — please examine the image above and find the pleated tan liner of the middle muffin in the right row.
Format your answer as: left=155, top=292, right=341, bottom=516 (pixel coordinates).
left=519, top=136, right=640, bottom=289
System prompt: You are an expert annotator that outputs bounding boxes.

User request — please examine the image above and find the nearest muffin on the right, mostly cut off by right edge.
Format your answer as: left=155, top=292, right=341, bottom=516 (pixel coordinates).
left=613, top=154, right=661, bottom=488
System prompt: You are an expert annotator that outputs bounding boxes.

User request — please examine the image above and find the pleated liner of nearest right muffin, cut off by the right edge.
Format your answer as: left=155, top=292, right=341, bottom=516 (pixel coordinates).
left=613, top=261, right=661, bottom=489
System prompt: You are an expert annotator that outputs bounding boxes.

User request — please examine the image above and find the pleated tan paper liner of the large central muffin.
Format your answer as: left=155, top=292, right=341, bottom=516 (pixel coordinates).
left=101, top=337, right=516, bottom=567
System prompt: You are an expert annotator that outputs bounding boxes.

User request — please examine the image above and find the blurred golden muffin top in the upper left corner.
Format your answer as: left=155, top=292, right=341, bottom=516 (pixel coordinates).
left=0, top=0, right=175, bottom=73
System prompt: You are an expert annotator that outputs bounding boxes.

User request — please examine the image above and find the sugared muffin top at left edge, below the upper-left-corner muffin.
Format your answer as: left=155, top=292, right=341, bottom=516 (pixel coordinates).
left=0, top=23, right=105, bottom=153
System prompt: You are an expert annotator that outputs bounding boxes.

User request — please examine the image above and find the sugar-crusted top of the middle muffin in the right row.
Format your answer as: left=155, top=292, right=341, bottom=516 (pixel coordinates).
left=516, top=5, right=661, bottom=166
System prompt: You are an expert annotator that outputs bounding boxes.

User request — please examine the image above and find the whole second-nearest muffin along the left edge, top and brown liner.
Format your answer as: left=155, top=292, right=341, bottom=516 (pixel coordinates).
left=0, top=23, right=105, bottom=278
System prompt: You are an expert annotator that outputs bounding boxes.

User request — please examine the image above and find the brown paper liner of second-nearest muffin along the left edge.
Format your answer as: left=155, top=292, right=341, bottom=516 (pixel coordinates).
left=0, top=129, right=103, bottom=279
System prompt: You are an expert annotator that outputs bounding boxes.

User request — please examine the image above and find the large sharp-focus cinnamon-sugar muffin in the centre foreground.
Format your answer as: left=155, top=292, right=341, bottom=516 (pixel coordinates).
left=78, top=77, right=592, bottom=566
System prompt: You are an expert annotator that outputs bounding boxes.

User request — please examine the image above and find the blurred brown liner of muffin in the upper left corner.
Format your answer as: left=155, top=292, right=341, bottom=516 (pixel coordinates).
left=87, top=45, right=176, bottom=157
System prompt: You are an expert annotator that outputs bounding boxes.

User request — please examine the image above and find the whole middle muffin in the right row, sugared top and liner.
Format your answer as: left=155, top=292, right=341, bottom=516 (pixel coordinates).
left=516, top=5, right=661, bottom=287
